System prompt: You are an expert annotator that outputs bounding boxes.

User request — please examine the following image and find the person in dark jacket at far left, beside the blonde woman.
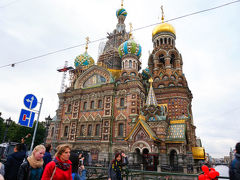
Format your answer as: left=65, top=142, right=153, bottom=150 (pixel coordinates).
left=4, top=144, right=26, bottom=180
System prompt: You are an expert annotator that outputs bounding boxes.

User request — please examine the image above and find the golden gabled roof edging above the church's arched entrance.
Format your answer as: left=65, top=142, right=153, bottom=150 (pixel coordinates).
left=125, top=115, right=160, bottom=141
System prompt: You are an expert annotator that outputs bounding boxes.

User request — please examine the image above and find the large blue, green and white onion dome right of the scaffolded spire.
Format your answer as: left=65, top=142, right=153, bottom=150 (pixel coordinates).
left=118, top=39, right=142, bottom=58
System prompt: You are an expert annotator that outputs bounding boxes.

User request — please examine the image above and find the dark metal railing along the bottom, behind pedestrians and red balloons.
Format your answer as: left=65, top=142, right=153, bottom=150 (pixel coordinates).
left=85, top=166, right=229, bottom=180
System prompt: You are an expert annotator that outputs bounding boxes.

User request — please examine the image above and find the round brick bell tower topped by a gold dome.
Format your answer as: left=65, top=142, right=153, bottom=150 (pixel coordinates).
left=148, top=7, right=196, bottom=152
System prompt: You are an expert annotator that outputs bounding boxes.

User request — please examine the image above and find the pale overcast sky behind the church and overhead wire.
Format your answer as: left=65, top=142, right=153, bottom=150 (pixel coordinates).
left=0, top=0, right=240, bottom=157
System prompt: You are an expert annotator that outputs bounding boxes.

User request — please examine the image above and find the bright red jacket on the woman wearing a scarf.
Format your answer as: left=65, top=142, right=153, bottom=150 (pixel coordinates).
left=42, top=158, right=72, bottom=180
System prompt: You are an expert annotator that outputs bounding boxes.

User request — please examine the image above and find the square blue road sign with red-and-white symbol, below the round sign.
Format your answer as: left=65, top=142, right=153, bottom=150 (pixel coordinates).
left=18, top=109, right=35, bottom=127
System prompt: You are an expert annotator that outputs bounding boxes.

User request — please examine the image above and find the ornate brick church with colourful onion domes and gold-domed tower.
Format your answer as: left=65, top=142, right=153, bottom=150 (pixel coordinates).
left=47, top=1, right=204, bottom=170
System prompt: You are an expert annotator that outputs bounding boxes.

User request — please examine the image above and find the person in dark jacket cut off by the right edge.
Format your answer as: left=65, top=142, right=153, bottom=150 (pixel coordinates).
left=229, top=142, right=240, bottom=180
